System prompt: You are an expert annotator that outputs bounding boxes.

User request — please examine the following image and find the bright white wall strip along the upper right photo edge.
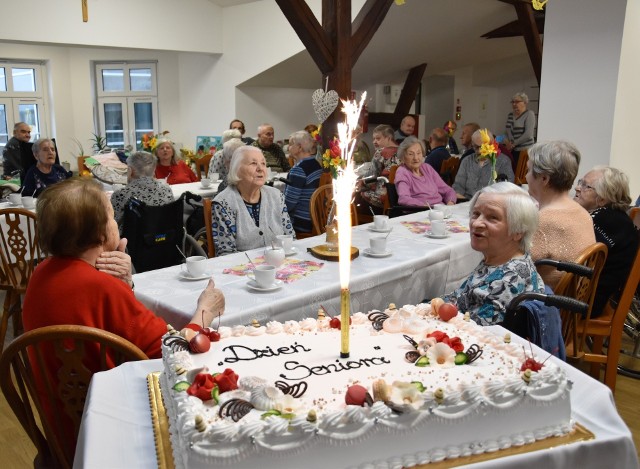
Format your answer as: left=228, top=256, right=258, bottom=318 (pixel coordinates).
left=611, top=0, right=640, bottom=197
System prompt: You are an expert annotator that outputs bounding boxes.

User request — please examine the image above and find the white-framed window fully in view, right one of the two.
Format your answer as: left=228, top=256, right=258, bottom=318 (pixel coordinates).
left=96, top=62, right=158, bottom=149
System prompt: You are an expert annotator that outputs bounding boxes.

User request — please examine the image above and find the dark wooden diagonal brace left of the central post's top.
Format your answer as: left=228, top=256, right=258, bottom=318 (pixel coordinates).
left=276, top=0, right=336, bottom=74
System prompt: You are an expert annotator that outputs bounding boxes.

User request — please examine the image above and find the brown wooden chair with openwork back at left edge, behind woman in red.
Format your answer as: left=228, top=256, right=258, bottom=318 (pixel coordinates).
left=0, top=208, right=41, bottom=350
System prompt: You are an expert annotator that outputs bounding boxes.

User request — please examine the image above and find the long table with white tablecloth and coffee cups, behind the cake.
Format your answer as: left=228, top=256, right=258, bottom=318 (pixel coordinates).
left=134, top=204, right=481, bottom=328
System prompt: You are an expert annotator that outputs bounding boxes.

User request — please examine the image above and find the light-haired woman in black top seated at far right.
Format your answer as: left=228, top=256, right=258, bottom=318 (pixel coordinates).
left=574, top=166, right=638, bottom=317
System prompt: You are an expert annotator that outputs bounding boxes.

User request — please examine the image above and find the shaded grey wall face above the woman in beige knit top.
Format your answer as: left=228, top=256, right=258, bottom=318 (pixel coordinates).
left=538, top=0, right=638, bottom=175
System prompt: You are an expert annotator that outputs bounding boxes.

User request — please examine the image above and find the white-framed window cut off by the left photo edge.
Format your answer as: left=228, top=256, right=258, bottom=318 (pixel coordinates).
left=0, top=59, right=46, bottom=151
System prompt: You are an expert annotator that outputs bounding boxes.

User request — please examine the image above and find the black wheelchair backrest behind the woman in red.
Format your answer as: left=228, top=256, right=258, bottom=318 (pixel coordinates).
left=122, top=194, right=185, bottom=273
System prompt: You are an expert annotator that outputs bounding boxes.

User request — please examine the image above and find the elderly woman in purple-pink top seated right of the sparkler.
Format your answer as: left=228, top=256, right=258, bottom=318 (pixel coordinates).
left=395, top=137, right=456, bottom=206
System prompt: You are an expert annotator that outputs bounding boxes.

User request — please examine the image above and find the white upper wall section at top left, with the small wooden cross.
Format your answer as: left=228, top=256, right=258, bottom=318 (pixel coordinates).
left=0, top=0, right=223, bottom=53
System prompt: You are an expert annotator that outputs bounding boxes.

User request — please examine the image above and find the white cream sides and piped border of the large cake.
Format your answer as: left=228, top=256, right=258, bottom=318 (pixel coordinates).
left=161, top=305, right=572, bottom=468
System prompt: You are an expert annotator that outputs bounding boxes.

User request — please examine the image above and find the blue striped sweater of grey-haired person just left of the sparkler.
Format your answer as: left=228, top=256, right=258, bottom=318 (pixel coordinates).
left=284, top=155, right=322, bottom=233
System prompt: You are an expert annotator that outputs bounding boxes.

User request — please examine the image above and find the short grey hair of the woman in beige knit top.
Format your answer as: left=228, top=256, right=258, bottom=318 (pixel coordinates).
left=528, top=140, right=580, bottom=191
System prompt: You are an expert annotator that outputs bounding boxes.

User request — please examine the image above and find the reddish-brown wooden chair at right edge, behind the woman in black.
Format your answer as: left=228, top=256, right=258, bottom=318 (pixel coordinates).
left=578, top=210, right=640, bottom=392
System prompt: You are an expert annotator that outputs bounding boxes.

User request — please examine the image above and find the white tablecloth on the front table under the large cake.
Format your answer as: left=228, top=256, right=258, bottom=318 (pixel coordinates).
left=74, top=326, right=638, bottom=469
